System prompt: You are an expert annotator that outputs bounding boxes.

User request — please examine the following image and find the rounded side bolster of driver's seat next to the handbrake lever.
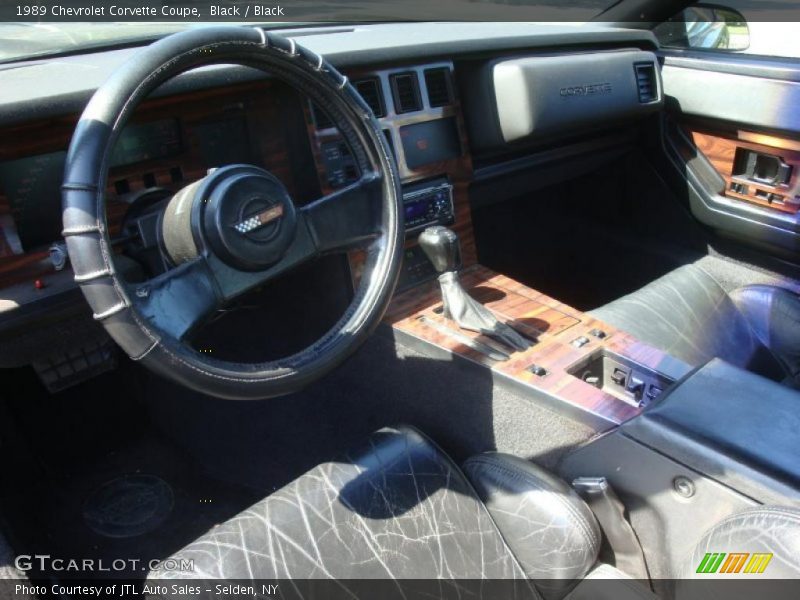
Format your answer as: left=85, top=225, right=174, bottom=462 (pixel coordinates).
left=464, top=452, right=602, bottom=598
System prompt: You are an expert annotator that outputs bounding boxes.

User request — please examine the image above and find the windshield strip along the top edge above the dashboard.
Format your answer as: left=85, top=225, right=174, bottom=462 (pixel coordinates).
left=0, top=0, right=615, bottom=62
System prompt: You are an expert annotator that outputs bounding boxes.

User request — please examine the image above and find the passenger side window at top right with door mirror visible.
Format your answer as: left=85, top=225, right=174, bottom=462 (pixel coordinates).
left=653, top=0, right=800, bottom=58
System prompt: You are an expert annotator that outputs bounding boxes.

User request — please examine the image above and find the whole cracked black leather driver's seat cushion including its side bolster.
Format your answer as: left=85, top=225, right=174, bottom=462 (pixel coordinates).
left=150, top=428, right=644, bottom=598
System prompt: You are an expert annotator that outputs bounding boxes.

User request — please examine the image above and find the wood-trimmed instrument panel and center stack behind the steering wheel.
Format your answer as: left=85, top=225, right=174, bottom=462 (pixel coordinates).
left=0, top=62, right=482, bottom=304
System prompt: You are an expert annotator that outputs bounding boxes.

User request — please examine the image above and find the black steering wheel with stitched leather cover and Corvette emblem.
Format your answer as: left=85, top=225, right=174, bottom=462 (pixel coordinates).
left=62, top=27, right=404, bottom=399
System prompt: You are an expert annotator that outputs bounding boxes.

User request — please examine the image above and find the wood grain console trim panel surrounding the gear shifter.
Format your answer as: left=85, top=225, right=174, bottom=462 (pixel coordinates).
left=385, top=264, right=689, bottom=429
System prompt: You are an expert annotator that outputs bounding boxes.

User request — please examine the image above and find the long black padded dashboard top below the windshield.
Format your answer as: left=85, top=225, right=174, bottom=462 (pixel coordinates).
left=0, top=23, right=658, bottom=125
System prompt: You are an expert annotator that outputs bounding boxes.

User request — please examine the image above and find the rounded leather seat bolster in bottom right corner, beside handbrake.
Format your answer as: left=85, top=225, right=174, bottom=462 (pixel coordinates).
left=683, top=506, right=800, bottom=579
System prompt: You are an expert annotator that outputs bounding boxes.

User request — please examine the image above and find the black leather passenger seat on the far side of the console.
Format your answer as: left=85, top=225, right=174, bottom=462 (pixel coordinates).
left=591, top=265, right=800, bottom=386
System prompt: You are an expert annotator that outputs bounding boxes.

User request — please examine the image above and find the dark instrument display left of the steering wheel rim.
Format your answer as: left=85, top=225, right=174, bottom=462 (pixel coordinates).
left=0, top=152, right=67, bottom=253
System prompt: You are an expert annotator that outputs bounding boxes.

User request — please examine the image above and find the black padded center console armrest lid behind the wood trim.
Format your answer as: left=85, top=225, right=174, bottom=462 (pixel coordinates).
left=623, top=359, right=800, bottom=502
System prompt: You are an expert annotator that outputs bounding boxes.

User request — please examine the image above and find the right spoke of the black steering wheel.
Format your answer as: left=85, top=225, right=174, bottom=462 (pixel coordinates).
left=301, top=172, right=383, bottom=254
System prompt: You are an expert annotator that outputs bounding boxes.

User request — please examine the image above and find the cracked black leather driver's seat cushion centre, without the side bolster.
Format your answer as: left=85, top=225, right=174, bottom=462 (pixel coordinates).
left=150, top=428, right=535, bottom=593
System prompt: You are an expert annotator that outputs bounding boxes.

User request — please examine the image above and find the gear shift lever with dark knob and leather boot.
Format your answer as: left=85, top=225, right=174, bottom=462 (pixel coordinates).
left=419, top=225, right=531, bottom=351
